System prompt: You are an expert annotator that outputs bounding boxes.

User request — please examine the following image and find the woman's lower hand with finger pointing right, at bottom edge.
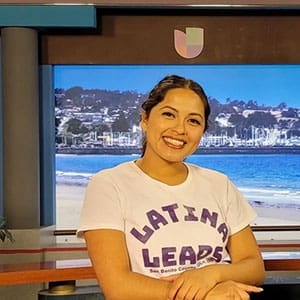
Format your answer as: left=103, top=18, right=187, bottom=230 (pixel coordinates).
left=204, top=281, right=263, bottom=300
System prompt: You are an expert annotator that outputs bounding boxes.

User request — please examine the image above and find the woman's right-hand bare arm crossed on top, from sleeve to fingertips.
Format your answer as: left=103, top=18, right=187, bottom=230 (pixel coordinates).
left=165, top=226, right=265, bottom=300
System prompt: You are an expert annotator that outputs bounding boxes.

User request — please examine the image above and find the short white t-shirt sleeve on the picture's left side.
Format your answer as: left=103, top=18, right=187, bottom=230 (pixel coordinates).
left=77, top=173, right=124, bottom=237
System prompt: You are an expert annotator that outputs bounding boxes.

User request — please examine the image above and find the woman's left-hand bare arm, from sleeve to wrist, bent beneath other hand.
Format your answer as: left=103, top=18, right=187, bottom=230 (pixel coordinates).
left=84, top=229, right=171, bottom=300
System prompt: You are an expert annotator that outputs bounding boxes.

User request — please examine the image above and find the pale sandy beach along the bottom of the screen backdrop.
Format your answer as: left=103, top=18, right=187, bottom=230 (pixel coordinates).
left=56, top=184, right=300, bottom=229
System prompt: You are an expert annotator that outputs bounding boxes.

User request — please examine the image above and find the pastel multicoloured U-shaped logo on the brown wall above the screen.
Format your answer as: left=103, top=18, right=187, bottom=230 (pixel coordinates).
left=174, top=27, right=204, bottom=58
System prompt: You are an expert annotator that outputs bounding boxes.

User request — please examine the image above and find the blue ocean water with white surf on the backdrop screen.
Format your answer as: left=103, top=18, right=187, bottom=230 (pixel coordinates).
left=56, top=154, right=300, bottom=209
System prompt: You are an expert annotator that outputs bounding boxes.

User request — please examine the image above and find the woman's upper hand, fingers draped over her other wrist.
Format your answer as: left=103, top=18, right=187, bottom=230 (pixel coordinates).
left=161, top=267, right=218, bottom=300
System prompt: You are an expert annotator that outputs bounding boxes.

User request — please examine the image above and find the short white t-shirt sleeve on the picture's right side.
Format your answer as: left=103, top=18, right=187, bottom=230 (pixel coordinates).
left=226, top=180, right=257, bottom=235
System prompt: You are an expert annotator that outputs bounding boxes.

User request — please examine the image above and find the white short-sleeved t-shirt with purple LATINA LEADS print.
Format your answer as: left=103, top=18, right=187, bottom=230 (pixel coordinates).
left=78, top=162, right=256, bottom=277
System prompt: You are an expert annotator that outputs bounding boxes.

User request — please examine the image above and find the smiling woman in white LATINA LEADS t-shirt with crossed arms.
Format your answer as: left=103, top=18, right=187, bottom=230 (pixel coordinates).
left=78, top=75, right=264, bottom=300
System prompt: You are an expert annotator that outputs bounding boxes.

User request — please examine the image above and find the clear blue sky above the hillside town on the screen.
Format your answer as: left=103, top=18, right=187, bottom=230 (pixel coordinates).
left=54, top=65, right=300, bottom=108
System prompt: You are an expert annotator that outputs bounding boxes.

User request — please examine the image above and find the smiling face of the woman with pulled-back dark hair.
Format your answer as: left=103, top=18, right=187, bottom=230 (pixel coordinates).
left=141, top=88, right=205, bottom=162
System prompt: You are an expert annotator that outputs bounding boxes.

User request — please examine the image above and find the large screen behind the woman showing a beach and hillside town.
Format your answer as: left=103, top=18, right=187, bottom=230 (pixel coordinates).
left=54, top=65, right=300, bottom=229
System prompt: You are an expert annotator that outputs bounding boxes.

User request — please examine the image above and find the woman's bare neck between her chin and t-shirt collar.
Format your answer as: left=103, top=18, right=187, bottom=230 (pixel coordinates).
left=136, top=157, right=188, bottom=185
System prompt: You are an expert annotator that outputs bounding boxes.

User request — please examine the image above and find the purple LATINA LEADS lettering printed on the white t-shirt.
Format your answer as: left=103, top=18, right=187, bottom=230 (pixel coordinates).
left=130, top=203, right=229, bottom=274
